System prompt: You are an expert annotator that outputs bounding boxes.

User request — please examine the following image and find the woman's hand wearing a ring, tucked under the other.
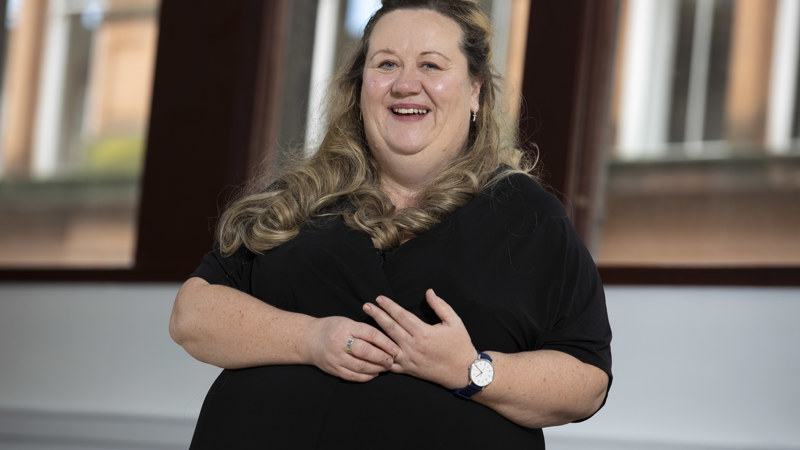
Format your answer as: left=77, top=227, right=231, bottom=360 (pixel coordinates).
left=307, top=316, right=400, bottom=383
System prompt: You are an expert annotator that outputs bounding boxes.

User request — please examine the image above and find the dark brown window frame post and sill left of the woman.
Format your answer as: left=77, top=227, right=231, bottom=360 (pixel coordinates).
left=0, top=0, right=286, bottom=282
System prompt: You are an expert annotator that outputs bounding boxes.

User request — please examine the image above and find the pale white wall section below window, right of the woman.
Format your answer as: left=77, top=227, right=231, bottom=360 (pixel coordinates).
left=550, top=287, right=800, bottom=449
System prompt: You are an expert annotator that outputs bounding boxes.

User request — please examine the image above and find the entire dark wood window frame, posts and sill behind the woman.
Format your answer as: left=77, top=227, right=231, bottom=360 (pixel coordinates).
left=0, top=0, right=800, bottom=286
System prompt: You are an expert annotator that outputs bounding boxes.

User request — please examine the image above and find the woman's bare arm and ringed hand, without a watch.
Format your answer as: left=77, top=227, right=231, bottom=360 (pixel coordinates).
left=169, top=277, right=399, bottom=382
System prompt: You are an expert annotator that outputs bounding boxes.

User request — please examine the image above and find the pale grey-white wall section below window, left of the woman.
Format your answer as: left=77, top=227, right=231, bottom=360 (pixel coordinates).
left=0, top=284, right=219, bottom=449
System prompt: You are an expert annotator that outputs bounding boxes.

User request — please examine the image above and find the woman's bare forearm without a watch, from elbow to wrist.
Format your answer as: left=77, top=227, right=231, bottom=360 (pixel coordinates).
left=169, top=278, right=314, bottom=369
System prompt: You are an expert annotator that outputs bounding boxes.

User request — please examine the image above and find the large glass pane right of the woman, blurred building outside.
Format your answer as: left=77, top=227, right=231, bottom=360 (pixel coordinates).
left=595, top=0, right=800, bottom=266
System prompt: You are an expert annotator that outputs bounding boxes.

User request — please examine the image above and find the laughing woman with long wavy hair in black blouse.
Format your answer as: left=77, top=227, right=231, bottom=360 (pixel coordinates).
left=170, top=0, right=611, bottom=448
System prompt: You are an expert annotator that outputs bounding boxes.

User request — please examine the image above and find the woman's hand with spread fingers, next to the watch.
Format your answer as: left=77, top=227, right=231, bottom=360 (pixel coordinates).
left=364, top=289, right=478, bottom=389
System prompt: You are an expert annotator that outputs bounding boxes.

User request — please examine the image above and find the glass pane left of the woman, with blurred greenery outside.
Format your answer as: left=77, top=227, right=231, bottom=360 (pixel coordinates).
left=0, top=0, right=158, bottom=268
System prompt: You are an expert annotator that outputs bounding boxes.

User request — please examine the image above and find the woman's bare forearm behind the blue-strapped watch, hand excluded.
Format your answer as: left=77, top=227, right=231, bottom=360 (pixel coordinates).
left=473, top=350, right=608, bottom=428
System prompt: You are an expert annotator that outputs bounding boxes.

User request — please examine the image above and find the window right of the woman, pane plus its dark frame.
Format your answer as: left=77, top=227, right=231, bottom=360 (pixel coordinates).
left=521, top=0, right=800, bottom=285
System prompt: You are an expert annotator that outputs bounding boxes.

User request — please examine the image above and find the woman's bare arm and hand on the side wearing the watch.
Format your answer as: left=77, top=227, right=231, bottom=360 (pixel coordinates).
left=364, top=290, right=608, bottom=428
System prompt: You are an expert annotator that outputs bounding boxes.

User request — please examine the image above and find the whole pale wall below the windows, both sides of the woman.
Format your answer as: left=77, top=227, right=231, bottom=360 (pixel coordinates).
left=0, top=284, right=800, bottom=450
